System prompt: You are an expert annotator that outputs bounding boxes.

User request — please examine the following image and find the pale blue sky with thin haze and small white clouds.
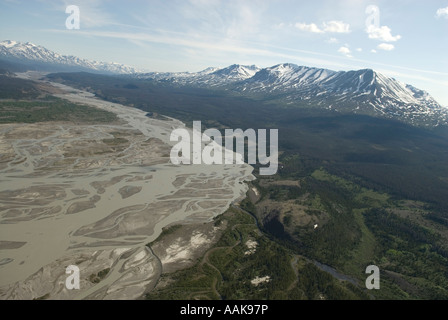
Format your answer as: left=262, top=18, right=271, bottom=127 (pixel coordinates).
left=0, top=0, right=448, bottom=106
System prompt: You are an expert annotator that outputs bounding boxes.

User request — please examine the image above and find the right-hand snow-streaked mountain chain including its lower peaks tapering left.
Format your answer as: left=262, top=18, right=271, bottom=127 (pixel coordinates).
left=138, top=63, right=448, bottom=125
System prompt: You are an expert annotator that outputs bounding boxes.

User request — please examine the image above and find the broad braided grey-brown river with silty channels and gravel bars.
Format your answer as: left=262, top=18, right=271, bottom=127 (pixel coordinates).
left=0, top=74, right=254, bottom=299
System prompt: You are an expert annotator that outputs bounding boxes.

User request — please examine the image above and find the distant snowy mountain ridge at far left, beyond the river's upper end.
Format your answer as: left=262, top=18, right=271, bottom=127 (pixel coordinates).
left=0, top=40, right=138, bottom=74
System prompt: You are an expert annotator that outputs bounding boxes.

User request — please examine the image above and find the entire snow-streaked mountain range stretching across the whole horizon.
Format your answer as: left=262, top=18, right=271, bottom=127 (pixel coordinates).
left=0, top=40, right=448, bottom=126
